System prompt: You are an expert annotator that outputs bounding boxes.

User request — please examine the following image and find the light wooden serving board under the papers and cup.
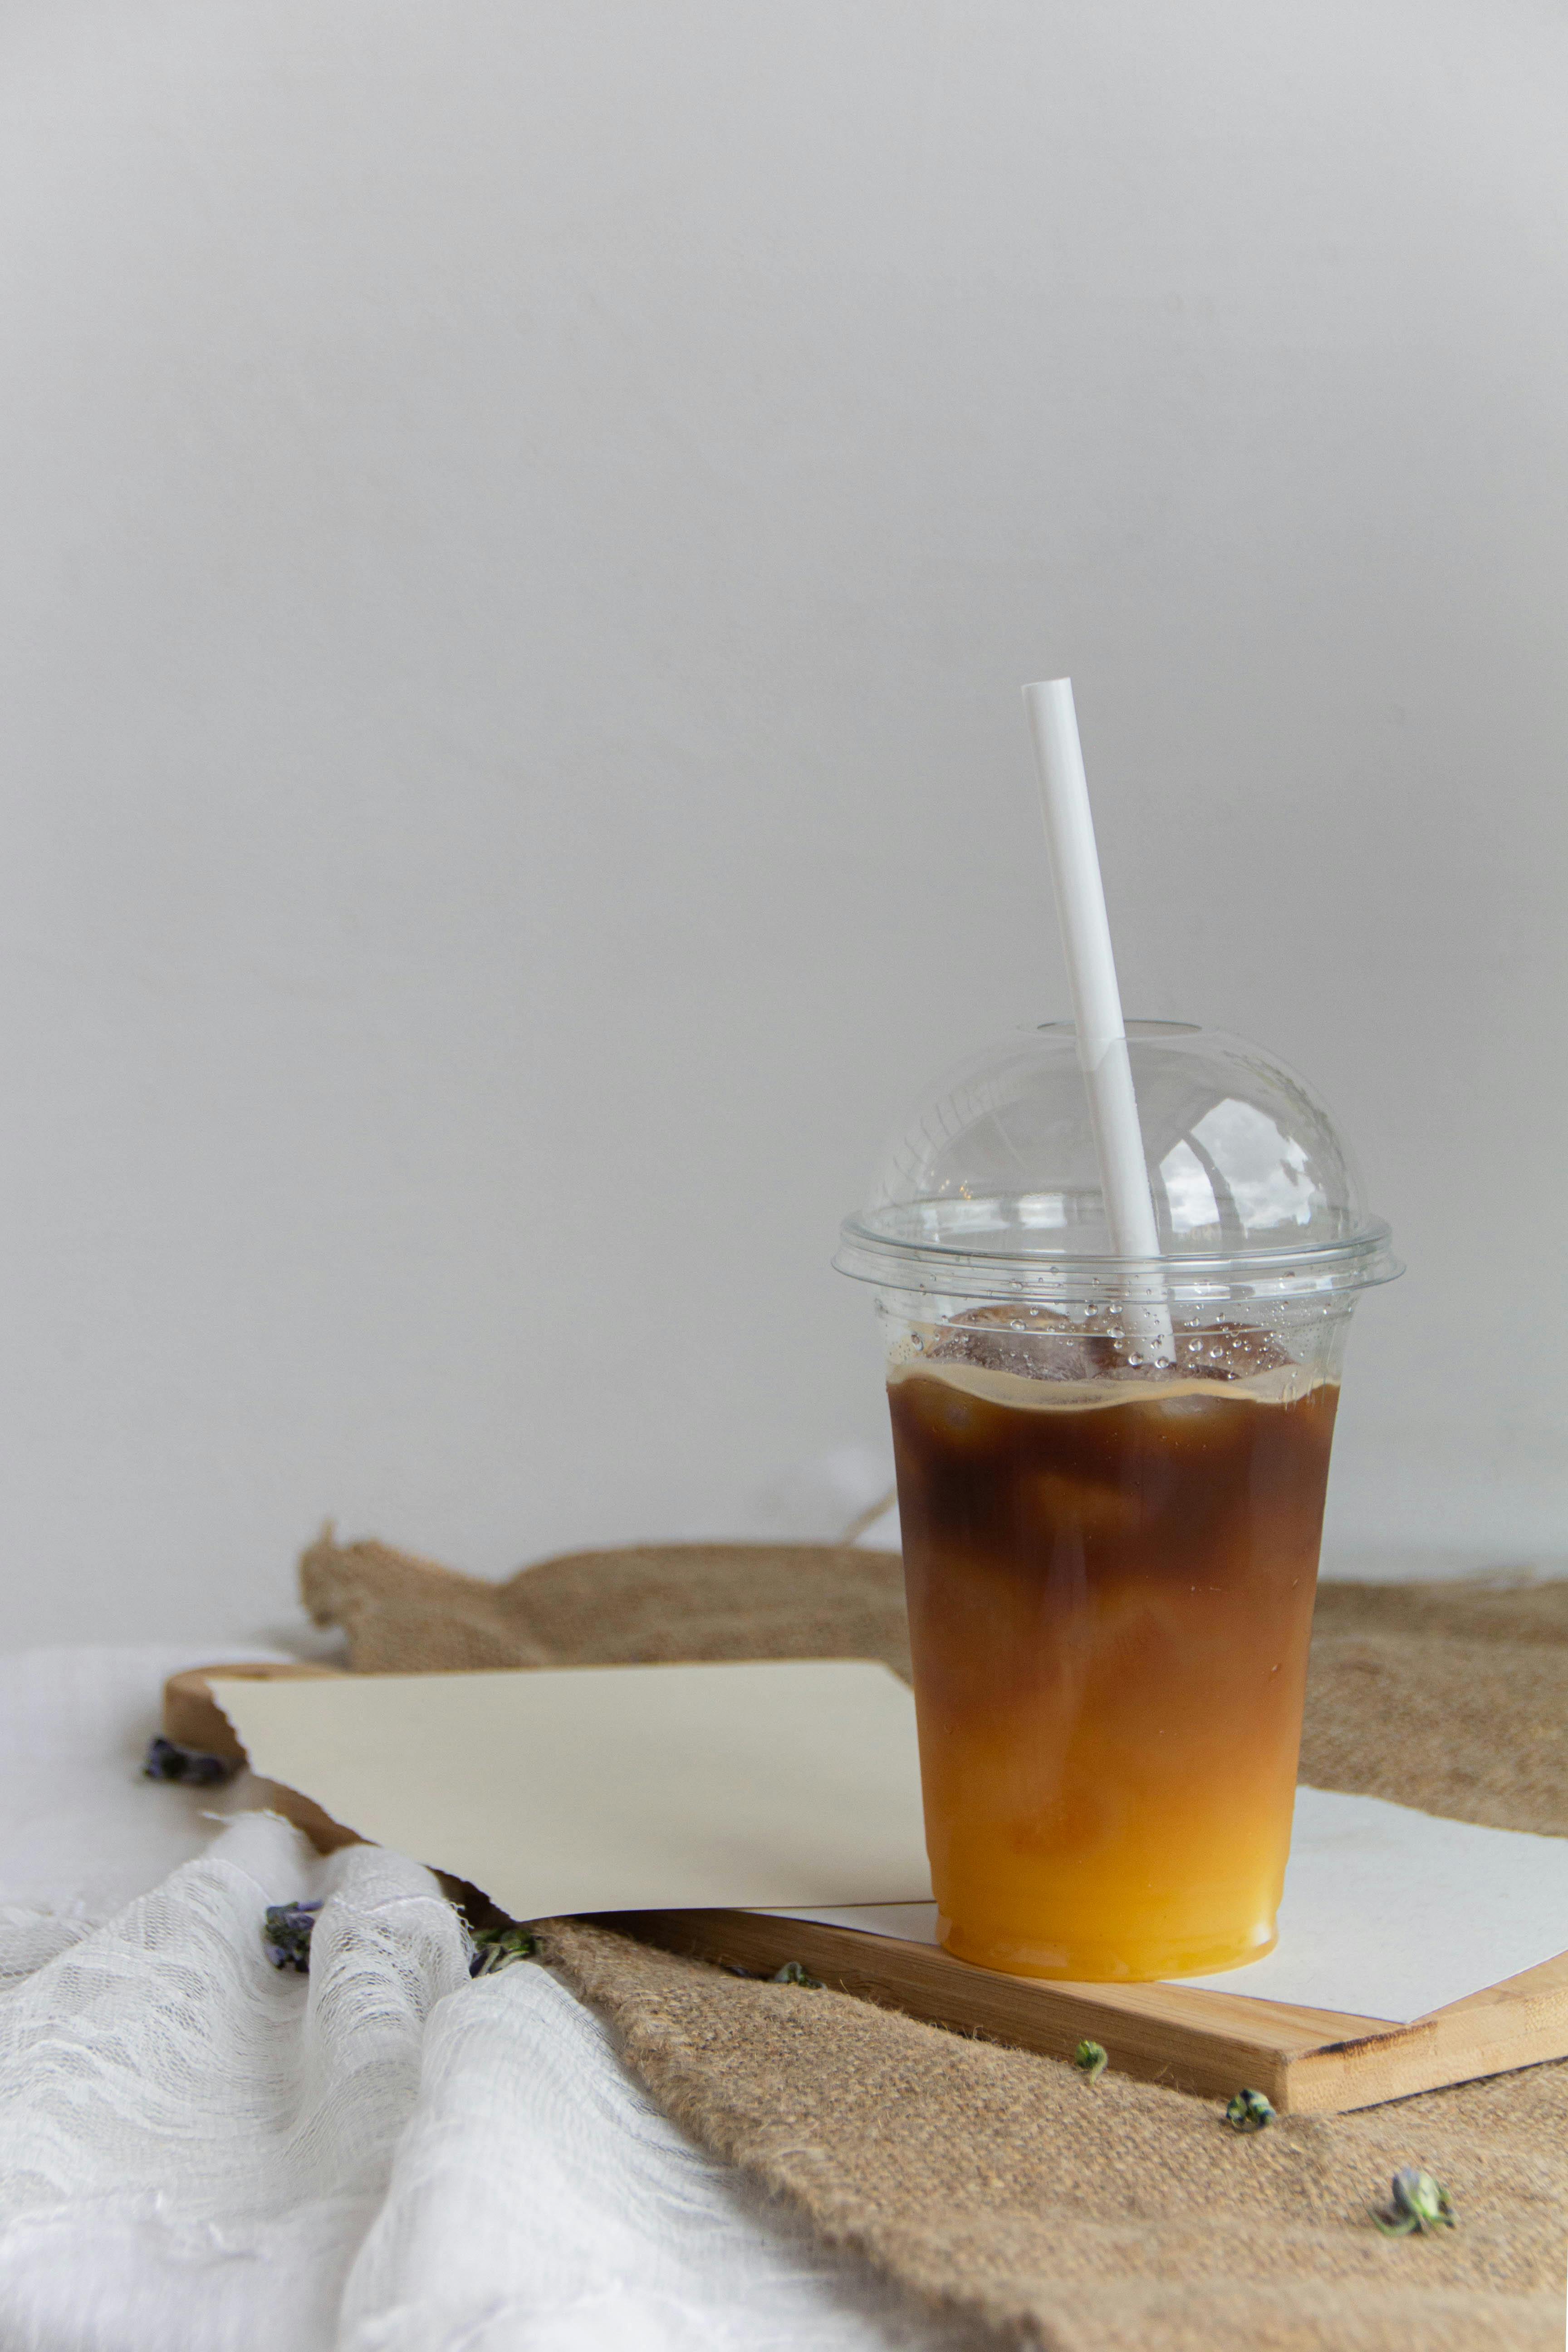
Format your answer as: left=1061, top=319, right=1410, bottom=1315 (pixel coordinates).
left=165, top=1665, right=1568, bottom=2114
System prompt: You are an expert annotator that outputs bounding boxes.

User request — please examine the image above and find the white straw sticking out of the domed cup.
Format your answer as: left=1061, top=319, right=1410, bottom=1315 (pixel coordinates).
left=1023, top=677, right=1176, bottom=1362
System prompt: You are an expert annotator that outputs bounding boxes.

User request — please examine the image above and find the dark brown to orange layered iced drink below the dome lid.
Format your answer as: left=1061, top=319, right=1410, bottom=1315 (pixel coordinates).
left=889, top=1305, right=1343, bottom=1980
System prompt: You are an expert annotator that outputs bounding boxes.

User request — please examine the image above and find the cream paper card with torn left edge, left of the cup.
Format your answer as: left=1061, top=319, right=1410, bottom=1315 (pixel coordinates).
left=211, top=1658, right=931, bottom=1919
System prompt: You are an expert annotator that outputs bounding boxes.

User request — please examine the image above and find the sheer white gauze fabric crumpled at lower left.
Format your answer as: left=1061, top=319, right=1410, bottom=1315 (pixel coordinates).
left=0, top=1651, right=973, bottom=2352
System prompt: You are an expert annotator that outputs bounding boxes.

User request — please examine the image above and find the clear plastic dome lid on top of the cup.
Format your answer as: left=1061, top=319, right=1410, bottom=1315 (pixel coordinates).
left=834, top=1021, right=1403, bottom=1305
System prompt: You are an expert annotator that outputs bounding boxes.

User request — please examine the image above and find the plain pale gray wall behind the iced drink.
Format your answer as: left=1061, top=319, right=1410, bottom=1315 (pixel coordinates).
left=0, top=0, right=1568, bottom=1642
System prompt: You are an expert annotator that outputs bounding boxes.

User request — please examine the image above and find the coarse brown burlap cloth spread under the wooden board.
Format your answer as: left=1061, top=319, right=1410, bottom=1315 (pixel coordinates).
left=301, top=1538, right=1568, bottom=2352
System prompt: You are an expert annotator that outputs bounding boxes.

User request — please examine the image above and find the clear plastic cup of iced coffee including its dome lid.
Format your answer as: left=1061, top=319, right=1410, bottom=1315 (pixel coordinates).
left=834, top=1023, right=1399, bottom=1980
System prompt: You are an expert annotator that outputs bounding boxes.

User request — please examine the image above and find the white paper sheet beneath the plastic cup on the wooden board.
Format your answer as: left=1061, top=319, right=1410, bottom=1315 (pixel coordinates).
left=769, top=1788, right=1568, bottom=2025
